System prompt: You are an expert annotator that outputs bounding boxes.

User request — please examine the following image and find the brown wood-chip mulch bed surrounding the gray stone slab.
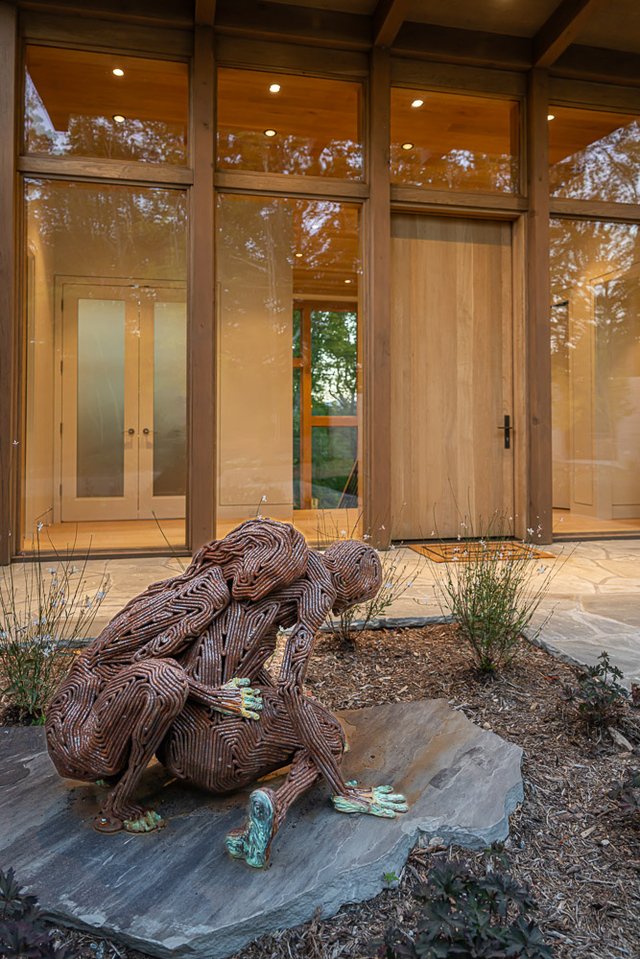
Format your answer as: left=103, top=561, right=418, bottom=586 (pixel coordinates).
left=13, top=625, right=640, bottom=959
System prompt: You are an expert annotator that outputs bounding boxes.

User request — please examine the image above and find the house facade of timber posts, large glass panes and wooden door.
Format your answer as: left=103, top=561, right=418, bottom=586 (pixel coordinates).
left=0, top=0, right=640, bottom=563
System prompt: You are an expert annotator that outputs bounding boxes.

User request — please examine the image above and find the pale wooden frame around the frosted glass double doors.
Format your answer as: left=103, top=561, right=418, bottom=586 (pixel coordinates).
left=52, top=274, right=185, bottom=523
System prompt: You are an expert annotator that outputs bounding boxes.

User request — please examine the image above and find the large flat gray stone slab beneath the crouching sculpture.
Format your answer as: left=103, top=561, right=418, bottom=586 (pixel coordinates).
left=0, top=700, right=523, bottom=959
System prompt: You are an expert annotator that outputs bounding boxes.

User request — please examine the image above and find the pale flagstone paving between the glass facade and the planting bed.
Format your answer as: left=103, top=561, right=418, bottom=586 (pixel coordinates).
left=36, top=539, right=640, bottom=685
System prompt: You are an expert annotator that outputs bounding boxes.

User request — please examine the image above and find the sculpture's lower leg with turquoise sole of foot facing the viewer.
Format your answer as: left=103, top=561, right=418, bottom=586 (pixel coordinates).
left=226, top=750, right=320, bottom=869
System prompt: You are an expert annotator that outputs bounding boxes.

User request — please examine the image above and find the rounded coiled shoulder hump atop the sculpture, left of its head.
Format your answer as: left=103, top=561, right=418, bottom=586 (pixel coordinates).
left=216, top=519, right=309, bottom=602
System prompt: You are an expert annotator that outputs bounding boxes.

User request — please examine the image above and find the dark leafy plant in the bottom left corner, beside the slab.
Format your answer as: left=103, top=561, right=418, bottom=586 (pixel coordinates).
left=0, top=869, right=74, bottom=959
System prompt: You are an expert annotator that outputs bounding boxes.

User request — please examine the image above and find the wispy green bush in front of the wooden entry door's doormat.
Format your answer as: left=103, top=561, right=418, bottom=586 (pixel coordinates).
left=431, top=514, right=555, bottom=674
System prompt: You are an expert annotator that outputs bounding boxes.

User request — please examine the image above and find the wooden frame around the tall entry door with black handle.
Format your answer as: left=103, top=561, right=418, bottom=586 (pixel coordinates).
left=387, top=208, right=538, bottom=540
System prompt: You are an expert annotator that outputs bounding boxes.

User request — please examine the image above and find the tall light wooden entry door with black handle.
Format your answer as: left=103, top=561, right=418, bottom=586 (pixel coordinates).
left=391, top=214, right=518, bottom=539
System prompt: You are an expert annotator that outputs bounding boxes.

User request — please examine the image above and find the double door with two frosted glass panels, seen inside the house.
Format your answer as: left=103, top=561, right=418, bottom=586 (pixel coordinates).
left=60, top=284, right=187, bottom=522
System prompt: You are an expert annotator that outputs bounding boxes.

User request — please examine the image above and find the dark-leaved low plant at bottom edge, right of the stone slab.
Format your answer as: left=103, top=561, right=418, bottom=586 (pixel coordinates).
left=380, top=863, right=553, bottom=959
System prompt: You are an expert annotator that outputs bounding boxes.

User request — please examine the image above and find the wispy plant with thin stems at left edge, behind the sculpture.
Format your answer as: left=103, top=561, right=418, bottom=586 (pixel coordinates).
left=0, top=529, right=109, bottom=724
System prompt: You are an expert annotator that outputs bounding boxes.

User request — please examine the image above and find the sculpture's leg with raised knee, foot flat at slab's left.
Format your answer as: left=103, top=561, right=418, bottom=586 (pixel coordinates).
left=90, top=659, right=188, bottom=832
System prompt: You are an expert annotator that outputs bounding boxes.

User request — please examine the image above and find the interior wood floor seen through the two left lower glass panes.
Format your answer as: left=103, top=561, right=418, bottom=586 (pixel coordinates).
left=23, top=509, right=361, bottom=553
